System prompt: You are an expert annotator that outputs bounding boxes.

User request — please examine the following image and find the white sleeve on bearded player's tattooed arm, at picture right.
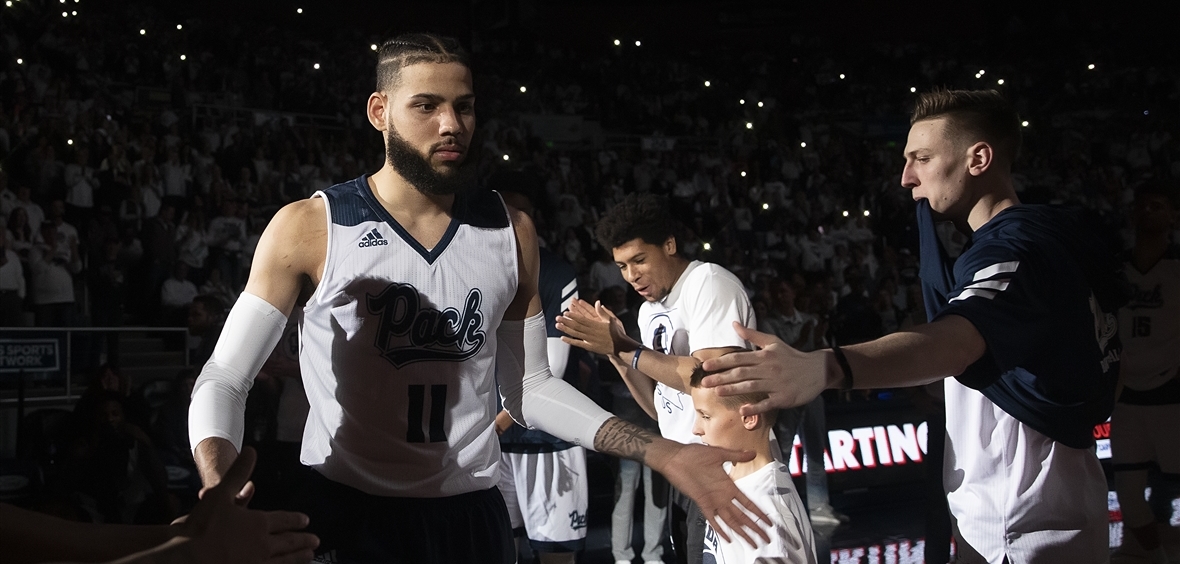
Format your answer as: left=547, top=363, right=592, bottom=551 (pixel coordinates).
left=496, top=314, right=614, bottom=450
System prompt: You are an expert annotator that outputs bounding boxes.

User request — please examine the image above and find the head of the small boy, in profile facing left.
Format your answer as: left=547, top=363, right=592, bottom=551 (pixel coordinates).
left=688, top=367, right=774, bottom=451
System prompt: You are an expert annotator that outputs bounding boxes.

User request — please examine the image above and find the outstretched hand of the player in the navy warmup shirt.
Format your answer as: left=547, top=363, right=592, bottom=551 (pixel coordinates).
left=701, top=322, right=827, bottom=415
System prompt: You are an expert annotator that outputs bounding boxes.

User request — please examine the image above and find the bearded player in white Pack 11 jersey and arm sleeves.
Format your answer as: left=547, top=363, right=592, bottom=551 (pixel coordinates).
left=189, top=35, right=766, bottom=563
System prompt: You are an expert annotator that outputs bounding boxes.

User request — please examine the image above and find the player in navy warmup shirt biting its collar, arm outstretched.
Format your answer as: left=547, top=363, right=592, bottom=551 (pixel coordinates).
left=704, top=91, right=1122, bottom=564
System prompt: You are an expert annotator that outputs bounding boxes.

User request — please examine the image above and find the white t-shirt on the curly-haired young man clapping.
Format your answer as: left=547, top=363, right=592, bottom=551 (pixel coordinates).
left=640, top=261, right=758, bottom=444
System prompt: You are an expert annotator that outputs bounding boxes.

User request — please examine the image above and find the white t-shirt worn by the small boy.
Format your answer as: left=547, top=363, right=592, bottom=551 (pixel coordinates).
left=704, top=461, right=817, bottom=564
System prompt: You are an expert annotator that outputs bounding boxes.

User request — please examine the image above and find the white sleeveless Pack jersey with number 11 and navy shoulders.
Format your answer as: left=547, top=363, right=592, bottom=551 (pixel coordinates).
left=300, top=176, right=518, bottom=497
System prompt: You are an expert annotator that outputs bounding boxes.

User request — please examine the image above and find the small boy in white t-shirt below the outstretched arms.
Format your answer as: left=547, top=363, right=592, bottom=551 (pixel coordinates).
left=689, top=368, right=817, bottom=564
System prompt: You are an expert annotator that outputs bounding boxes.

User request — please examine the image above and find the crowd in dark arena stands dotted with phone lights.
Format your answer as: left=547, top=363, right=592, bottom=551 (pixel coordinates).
left=0, top=0, right=1180, bottom=528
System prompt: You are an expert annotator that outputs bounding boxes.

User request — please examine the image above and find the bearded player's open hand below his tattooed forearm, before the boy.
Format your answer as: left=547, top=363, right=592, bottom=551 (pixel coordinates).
left=660, top=445, right=773, bottom=549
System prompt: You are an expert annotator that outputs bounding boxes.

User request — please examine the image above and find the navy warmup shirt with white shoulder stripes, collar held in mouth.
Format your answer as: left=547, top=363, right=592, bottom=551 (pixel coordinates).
left=918, top=199, right=1122, bottom=448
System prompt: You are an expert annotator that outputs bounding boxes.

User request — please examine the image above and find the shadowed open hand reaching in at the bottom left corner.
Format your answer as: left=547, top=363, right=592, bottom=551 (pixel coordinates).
left=177, top=447, right=320, bottom=564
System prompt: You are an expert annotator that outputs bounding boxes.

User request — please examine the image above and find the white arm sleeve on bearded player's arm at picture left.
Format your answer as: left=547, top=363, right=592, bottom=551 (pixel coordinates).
left=189, top=291, right=287, bottom=452
